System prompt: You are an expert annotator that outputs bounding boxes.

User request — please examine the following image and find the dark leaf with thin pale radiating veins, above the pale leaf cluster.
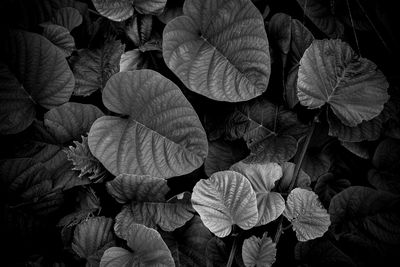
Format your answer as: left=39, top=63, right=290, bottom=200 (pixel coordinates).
left=226, top=99, right=307, bottom=163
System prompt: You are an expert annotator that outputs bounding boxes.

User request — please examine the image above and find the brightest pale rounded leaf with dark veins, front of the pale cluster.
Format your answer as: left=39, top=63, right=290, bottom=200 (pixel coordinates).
left=192, top=171, right=258, bottom=237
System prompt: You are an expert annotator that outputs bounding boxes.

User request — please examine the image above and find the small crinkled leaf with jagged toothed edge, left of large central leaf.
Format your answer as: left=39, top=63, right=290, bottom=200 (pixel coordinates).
left=64, top=136, right=107, bottom=182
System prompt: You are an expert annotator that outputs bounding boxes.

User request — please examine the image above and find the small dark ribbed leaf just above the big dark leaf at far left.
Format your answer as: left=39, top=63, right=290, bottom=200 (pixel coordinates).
left=40, top=23, right=75, bottom=57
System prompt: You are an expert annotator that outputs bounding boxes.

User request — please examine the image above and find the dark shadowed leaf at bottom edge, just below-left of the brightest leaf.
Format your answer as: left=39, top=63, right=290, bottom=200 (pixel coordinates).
left=161, top=215, right=213, bottom=267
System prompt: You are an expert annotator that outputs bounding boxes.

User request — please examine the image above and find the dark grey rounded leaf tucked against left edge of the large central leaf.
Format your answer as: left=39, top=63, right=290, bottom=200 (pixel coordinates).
left=44, top=102, right=104, bottom=144
